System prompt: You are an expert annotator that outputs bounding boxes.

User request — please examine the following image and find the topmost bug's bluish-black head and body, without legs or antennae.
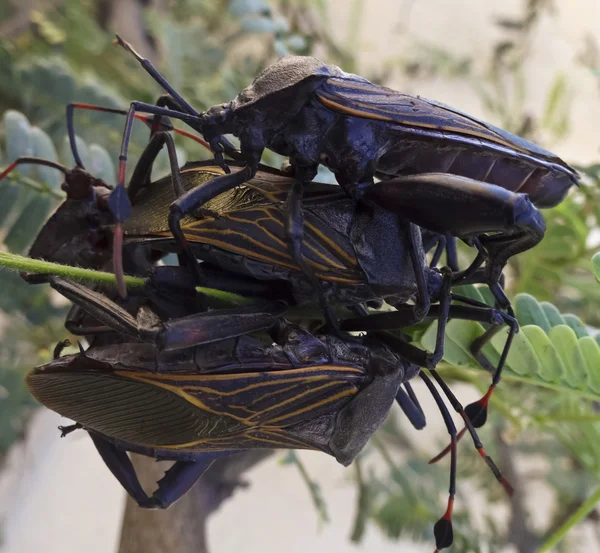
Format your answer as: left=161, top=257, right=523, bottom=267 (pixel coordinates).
left=203, top=56, right=577, bottom=207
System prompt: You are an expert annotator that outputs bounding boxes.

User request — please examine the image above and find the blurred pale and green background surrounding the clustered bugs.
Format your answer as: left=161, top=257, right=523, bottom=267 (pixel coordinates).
left=0, top=0, right=600, bottom=553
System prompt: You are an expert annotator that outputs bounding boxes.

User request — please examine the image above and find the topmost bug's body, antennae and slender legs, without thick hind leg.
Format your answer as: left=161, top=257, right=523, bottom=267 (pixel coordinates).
left=110, top=36, right=577, bottom=310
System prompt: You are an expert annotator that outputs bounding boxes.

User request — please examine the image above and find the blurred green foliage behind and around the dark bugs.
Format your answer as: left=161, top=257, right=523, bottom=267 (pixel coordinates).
left=0, top=0, right=600, bottom=553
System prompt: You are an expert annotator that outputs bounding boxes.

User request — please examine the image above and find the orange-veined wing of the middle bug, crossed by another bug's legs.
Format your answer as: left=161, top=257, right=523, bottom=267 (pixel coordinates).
left=124, top=167, right=364, bottom=284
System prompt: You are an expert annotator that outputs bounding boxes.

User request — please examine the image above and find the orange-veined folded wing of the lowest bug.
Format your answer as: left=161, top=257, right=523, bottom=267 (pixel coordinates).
left=26, top=356, right=365, bottom=451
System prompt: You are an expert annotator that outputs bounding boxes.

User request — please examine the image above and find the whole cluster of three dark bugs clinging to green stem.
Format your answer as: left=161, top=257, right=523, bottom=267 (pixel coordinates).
left=7, top=39, right=576, bottom=550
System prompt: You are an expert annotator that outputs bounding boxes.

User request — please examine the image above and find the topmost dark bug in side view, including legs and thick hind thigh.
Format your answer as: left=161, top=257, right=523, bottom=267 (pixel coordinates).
left=59, top=37, right=577, bottom=436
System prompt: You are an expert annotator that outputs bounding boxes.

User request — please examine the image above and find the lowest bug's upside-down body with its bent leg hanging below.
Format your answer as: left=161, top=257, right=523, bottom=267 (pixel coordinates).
left=26, top=326, right=419, bottom=508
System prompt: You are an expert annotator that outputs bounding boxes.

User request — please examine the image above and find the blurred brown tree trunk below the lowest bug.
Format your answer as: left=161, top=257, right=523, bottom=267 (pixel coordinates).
left=119, top=450, right=271, bottom=553
